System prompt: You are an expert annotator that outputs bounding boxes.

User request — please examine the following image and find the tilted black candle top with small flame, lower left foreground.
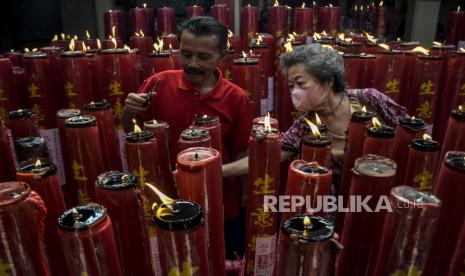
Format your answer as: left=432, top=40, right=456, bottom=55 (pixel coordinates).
left=58, top=203, right=107, bottom=232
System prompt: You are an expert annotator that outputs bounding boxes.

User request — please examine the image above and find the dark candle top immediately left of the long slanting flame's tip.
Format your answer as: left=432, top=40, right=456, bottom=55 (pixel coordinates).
left=97, top=171, right=139, bottom=190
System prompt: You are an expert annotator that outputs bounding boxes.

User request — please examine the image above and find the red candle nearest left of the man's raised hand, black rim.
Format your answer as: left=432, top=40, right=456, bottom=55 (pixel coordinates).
left=82, top=101, right=121, bottom=171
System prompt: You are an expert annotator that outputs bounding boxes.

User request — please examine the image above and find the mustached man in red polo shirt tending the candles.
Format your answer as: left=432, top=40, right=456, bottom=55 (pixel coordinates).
left=121, top=17, right=252, bottom=258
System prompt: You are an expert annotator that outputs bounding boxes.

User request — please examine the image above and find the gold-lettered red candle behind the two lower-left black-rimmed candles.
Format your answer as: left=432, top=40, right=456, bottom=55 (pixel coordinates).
left=64, top=115, right=104, bottom=206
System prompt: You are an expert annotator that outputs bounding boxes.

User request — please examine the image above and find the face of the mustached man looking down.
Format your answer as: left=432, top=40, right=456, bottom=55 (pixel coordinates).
left=180, top=30, right=222, bottom=84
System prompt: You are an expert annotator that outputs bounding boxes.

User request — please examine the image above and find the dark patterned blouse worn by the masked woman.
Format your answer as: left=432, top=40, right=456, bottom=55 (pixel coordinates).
left=281, top=88, right=407, bottom=190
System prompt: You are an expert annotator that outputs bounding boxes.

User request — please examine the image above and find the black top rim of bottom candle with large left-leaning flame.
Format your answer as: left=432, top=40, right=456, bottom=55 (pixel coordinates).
left=154, top=200, right=204, bottom=231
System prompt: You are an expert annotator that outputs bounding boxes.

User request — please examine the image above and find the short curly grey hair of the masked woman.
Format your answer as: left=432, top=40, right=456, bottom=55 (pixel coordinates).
left=280, top=43, right=345, bottom=92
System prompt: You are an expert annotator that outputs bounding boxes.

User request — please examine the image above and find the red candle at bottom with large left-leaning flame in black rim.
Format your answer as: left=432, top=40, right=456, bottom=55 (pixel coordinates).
left=154, top=200, right=209, bottom=275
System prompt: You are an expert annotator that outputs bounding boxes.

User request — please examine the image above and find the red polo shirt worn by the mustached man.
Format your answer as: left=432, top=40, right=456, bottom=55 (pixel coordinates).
left=139, top=69, right=252, bottom=219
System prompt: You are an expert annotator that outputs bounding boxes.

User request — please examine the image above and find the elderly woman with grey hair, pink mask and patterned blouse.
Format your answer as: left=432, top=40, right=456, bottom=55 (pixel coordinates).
left=223, top=44, right=406, bottom=185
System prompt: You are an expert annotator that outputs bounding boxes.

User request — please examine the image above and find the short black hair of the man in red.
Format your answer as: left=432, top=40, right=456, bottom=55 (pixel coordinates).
left=178, top=16, right=228, bottom=52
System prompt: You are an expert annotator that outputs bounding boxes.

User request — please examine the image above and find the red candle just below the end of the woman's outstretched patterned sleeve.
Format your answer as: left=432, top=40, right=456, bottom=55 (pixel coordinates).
left=392, top=117, right=426, bottom=184
